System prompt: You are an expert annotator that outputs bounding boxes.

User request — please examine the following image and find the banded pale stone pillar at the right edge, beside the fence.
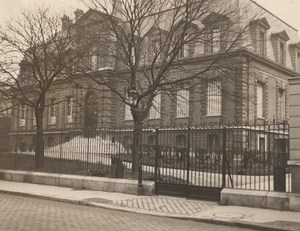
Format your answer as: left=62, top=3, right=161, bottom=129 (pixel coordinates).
left=288, top=77, right=300, bottom=193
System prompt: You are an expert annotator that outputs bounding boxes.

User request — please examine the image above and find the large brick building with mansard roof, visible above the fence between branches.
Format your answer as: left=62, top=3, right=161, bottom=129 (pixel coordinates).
left=8, top=1, right=300, bottom=149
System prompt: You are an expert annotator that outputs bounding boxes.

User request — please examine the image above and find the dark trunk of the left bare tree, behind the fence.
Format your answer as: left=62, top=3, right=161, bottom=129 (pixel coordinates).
left=35, top=109, right=44, bottom=169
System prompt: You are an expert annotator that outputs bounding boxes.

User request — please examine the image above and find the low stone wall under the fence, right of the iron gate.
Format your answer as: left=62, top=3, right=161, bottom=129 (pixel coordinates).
left=220, top=188, right=300, bottom=212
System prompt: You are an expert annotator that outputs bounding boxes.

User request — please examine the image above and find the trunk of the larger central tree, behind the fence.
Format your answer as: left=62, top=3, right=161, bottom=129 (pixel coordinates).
left=132, top=118, right=143, bottom=178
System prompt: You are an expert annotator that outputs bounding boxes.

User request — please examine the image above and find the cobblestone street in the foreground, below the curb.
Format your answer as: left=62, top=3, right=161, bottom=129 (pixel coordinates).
left=0, top=194, right=255, bottom=231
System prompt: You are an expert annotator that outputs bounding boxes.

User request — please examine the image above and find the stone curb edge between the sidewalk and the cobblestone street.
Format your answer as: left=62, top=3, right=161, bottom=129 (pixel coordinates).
left=0, top=190, right=292, bottom=231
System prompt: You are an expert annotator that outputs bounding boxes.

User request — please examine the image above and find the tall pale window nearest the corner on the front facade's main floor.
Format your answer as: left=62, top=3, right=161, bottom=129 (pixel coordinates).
left=207, top=80, right=222, bottom=116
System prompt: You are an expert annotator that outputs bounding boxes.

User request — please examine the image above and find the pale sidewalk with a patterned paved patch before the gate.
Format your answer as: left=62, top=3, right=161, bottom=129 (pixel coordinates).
left=0, top=181, right=300, bottom=230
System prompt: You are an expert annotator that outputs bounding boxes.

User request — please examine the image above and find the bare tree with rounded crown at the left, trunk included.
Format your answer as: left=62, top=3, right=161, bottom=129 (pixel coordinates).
left=0, top=7, right=76, bottom=168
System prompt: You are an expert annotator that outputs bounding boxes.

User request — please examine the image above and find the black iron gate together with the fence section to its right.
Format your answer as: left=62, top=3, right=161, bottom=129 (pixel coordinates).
left=152, top=123, right=290, bottom=201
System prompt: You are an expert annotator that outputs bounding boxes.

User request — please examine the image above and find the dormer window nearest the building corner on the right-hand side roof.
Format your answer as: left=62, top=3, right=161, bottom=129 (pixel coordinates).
left=250, top=18, right=271, bottom=56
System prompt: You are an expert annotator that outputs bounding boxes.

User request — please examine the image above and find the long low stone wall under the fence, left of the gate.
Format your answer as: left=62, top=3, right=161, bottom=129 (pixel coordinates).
left=0, top=170, right=155, bottom=195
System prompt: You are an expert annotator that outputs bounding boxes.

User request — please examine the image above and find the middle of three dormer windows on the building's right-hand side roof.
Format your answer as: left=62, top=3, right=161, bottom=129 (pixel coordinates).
left=271, top=30, right=290, bottom=66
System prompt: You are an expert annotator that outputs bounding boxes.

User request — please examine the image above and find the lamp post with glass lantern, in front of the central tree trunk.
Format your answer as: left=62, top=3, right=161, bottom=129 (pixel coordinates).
left=128, top=88, right=143, bottom=195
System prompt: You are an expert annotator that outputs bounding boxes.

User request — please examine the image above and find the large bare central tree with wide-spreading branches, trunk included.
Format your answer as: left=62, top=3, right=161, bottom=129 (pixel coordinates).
left=72, top=0, right=258, bottom=174
